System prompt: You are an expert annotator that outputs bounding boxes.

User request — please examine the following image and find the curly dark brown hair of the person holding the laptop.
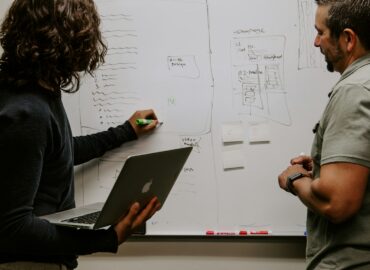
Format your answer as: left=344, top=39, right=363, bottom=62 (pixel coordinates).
left=0, top=0, right=107, bottom=92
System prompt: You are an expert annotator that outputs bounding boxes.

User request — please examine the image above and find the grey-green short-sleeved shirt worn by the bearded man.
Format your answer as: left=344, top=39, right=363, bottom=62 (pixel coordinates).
left=307, top=54, right=370, bottom=270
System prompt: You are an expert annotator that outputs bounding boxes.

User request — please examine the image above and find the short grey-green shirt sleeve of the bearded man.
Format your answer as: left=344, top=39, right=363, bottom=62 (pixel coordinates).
left=321, top=84, right=370, bottom=167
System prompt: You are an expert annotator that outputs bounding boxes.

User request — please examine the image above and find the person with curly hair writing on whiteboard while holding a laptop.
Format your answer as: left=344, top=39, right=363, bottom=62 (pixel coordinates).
left=0, top=0, right=160, bottom=270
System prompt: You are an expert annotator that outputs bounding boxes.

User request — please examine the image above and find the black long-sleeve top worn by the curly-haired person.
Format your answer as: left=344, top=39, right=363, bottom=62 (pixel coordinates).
left=0, top=85, right=136, bottom=268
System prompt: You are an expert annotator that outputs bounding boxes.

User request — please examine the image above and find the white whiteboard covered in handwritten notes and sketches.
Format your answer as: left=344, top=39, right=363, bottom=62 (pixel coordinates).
left=64, top=0, right=337, bottom=235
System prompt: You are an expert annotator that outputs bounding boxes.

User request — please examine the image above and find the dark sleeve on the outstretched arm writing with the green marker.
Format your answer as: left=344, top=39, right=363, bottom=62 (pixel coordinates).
left=73, top=121, right=137, bottom=165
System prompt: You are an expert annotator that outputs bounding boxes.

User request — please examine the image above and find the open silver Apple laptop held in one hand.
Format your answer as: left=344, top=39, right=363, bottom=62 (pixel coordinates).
left=40, top=147, right=192, bottom=229
